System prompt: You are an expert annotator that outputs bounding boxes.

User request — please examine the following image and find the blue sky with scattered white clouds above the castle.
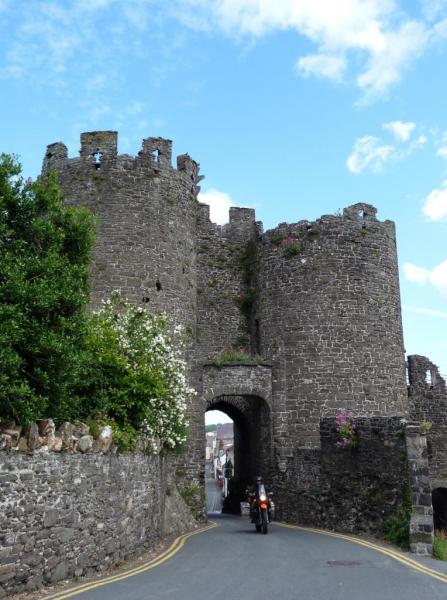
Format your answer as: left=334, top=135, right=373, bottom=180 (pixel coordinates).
left=0, top=0, right=447, bottom=374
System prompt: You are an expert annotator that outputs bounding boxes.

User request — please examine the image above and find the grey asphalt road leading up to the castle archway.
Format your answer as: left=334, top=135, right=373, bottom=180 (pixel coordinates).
left=52, top=515, right=447, bottom=600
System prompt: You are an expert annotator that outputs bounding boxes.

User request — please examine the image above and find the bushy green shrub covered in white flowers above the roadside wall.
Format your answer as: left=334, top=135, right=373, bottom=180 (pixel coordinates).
left=84, top=292, right=195, bottom=450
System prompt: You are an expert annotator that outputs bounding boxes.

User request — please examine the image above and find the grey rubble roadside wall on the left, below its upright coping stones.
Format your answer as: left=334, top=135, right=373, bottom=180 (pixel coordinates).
left=0, top=452, right=167, bottom=598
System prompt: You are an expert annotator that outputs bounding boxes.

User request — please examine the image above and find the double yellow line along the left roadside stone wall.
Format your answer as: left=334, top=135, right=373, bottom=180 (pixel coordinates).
left=44, top=521, right=218, bottom=600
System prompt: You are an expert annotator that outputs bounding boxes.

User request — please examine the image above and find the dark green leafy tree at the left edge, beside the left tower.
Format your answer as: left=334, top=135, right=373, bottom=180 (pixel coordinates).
left=0, top=154, right=94, bottom=425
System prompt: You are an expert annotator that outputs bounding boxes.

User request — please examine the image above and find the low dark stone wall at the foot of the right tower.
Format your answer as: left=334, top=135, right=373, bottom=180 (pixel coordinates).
left=277, top=417, right=408, bottom=534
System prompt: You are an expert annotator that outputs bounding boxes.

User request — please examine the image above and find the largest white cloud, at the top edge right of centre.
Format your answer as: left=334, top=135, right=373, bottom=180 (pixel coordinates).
left=173, top=0, right=441, bottom=101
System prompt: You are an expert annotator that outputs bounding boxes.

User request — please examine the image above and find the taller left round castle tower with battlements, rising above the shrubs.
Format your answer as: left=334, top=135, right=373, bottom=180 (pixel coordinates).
left=43, top=132, right=200, bottom=327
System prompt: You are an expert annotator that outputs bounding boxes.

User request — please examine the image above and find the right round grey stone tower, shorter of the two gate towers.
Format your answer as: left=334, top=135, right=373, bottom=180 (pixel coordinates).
left=257, top=204, right=407, bottom=456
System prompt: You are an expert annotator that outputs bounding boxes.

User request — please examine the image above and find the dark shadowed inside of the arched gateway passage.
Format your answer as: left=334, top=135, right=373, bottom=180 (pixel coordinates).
left=206, top=395, right=272, bottom=513
